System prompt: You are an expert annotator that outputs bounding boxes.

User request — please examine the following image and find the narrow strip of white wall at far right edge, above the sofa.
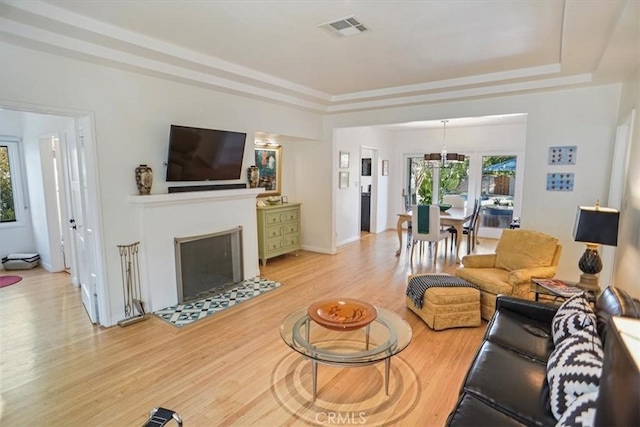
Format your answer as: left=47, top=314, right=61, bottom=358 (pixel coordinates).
left=613, top=68, right=640, bottom=298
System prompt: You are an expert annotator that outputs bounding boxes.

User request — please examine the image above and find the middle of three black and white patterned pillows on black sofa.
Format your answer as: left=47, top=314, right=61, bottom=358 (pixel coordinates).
left=547, top=326, right=604, bottom=420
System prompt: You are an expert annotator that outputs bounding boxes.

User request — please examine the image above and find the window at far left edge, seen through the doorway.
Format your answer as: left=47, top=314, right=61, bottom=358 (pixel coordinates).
left=0, top=139, right=21, bottom=225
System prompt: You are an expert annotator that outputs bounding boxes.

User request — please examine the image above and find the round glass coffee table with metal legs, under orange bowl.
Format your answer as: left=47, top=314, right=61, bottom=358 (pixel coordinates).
left=280, top=307, right=413, bottom=401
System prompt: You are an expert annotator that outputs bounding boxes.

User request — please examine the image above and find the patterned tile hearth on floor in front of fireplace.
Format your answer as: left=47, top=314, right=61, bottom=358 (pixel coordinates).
left=154, top=277, right=281, bottom=328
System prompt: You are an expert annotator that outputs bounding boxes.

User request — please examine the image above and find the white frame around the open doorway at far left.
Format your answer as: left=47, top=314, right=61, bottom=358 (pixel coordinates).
left=0, top=99, right=112, bottom=326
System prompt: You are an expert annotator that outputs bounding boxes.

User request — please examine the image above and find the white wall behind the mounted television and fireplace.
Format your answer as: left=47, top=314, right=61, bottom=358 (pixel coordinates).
left=0, top=44, right=320, bottom=324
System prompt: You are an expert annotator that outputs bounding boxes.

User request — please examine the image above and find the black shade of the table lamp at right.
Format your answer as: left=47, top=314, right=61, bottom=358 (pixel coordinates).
left=573, top=206, right=620, bottom=246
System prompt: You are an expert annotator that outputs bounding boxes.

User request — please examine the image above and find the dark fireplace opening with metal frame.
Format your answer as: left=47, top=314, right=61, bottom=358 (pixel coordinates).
left=174, top=227, right=244, bottom=304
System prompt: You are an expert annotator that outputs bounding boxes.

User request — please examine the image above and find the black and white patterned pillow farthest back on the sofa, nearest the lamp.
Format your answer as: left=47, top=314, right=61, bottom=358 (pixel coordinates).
left=551, top=293, right=597, bottom=347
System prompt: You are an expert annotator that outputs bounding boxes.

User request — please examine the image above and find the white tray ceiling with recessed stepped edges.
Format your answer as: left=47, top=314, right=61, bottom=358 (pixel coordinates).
left=0, top=0, right=640, bottom=113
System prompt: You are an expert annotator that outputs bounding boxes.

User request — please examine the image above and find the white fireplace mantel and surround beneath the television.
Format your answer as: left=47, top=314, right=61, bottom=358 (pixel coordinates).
left=128, top=188, right=264, bottom=311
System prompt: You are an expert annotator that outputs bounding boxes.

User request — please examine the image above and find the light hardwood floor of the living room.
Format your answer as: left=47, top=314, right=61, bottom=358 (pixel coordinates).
left=0, top=231, right=495, bottom=427
